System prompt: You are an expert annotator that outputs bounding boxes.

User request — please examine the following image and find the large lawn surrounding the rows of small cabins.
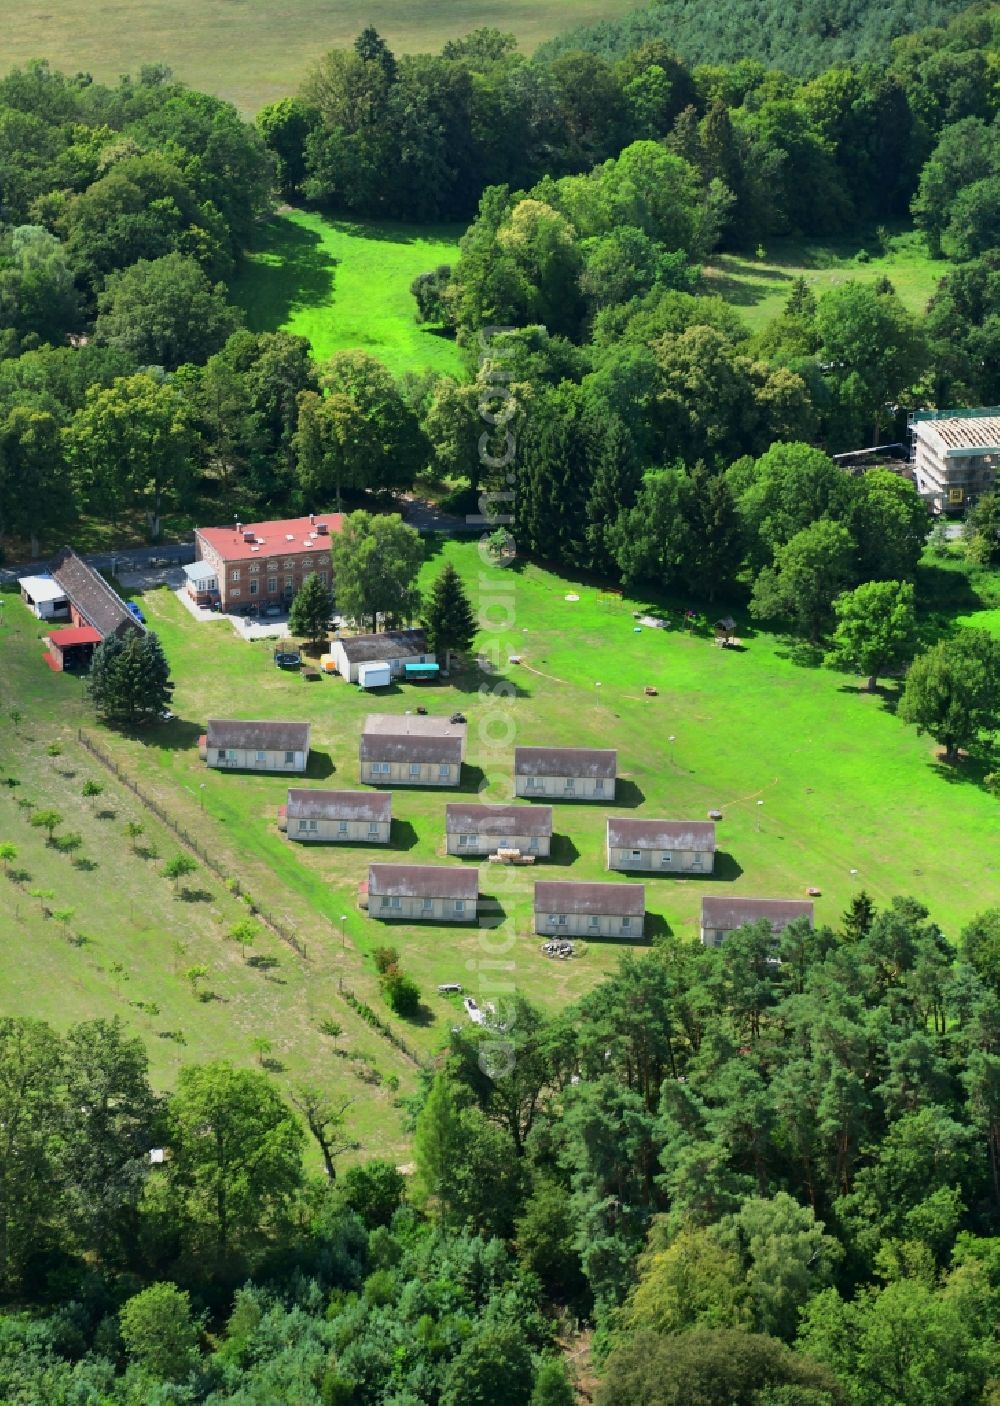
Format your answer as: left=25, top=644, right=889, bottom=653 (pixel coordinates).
left=7, top=544, right=1000, bottom=1153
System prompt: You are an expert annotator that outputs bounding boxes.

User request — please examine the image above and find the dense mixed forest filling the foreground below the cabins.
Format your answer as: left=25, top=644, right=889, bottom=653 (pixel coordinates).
left=0, top=893, right=1000, bottom=1406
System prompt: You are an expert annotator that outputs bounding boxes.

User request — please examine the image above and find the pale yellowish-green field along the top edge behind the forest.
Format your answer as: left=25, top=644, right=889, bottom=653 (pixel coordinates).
left=0, top=0, right=633, bottom=115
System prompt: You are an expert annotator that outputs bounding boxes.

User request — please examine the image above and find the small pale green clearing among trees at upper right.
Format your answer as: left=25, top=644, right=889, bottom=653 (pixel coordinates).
left=705, top=232, right=948, bottom=332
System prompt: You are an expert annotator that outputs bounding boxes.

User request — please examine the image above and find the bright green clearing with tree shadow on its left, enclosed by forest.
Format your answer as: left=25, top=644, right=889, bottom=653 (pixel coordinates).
left=232, top=211, right=463, bottom=375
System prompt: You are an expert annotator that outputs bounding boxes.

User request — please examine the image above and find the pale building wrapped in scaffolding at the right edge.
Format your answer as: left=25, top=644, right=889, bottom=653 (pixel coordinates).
left=910, top=406, right=1000, bottom=513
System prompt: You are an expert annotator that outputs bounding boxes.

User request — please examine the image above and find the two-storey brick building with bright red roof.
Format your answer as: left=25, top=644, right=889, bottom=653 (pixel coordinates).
left=190, top=513, right=343, bottom=610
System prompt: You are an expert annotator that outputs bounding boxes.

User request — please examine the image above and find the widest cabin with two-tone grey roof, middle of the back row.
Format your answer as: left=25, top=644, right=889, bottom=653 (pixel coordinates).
left=359, top=713, right=466, bottom=786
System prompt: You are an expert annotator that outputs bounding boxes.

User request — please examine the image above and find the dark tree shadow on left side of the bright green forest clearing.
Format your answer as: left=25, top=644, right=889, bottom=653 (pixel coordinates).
left=232, top=217, right=338, bottom=332
